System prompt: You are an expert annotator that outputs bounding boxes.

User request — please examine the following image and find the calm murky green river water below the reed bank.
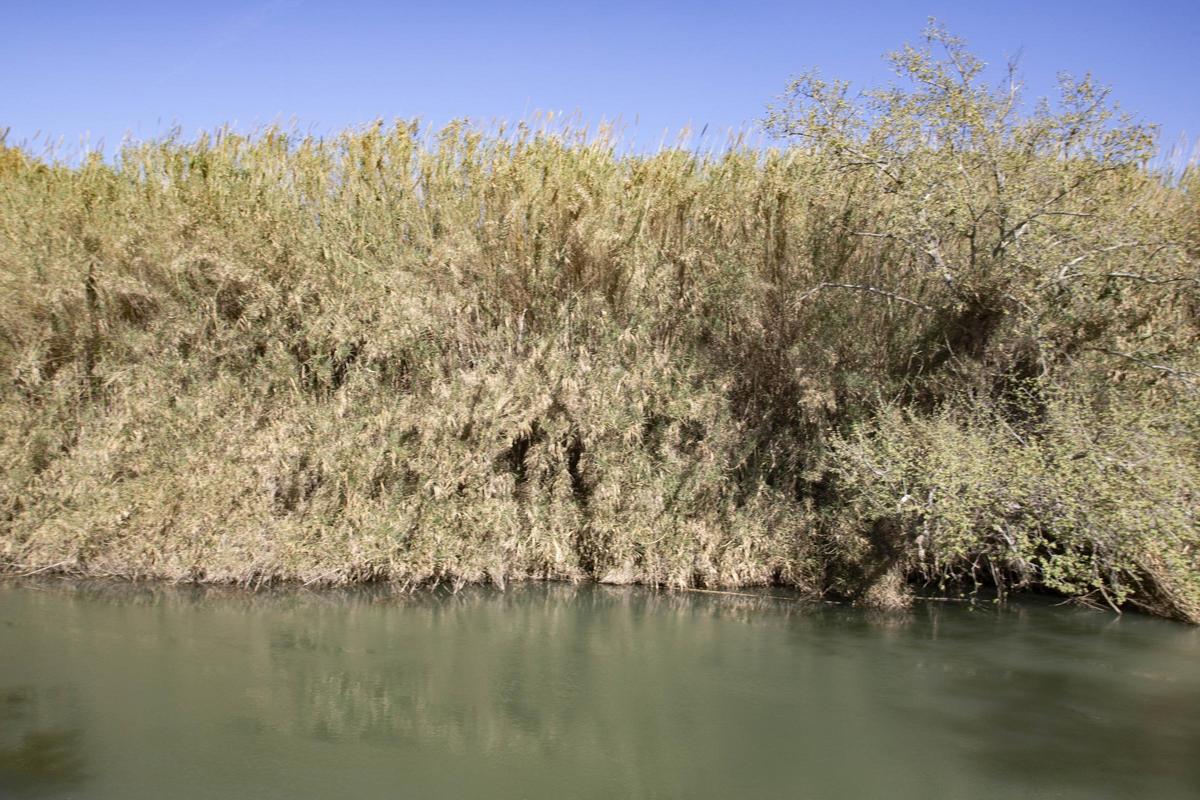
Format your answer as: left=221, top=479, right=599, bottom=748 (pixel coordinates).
left=0, top=584, right=1200, bottom=800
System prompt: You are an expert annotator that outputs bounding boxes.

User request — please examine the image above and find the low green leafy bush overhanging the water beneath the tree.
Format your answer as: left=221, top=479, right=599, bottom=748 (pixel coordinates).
left=833, top=399, right=1200, bottom=620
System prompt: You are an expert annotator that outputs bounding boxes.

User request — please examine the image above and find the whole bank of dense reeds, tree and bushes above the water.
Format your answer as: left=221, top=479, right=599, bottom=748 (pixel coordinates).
left=0, top=29, right=1200, bottom=620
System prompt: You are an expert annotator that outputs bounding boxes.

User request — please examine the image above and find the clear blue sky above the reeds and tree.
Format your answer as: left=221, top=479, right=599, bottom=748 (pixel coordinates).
left=0, top=0, right=1200, bottom=150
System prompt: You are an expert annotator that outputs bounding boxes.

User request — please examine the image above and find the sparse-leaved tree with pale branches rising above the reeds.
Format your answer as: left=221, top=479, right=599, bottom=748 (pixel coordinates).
left=766, top=20, right=1196, bottom=400
